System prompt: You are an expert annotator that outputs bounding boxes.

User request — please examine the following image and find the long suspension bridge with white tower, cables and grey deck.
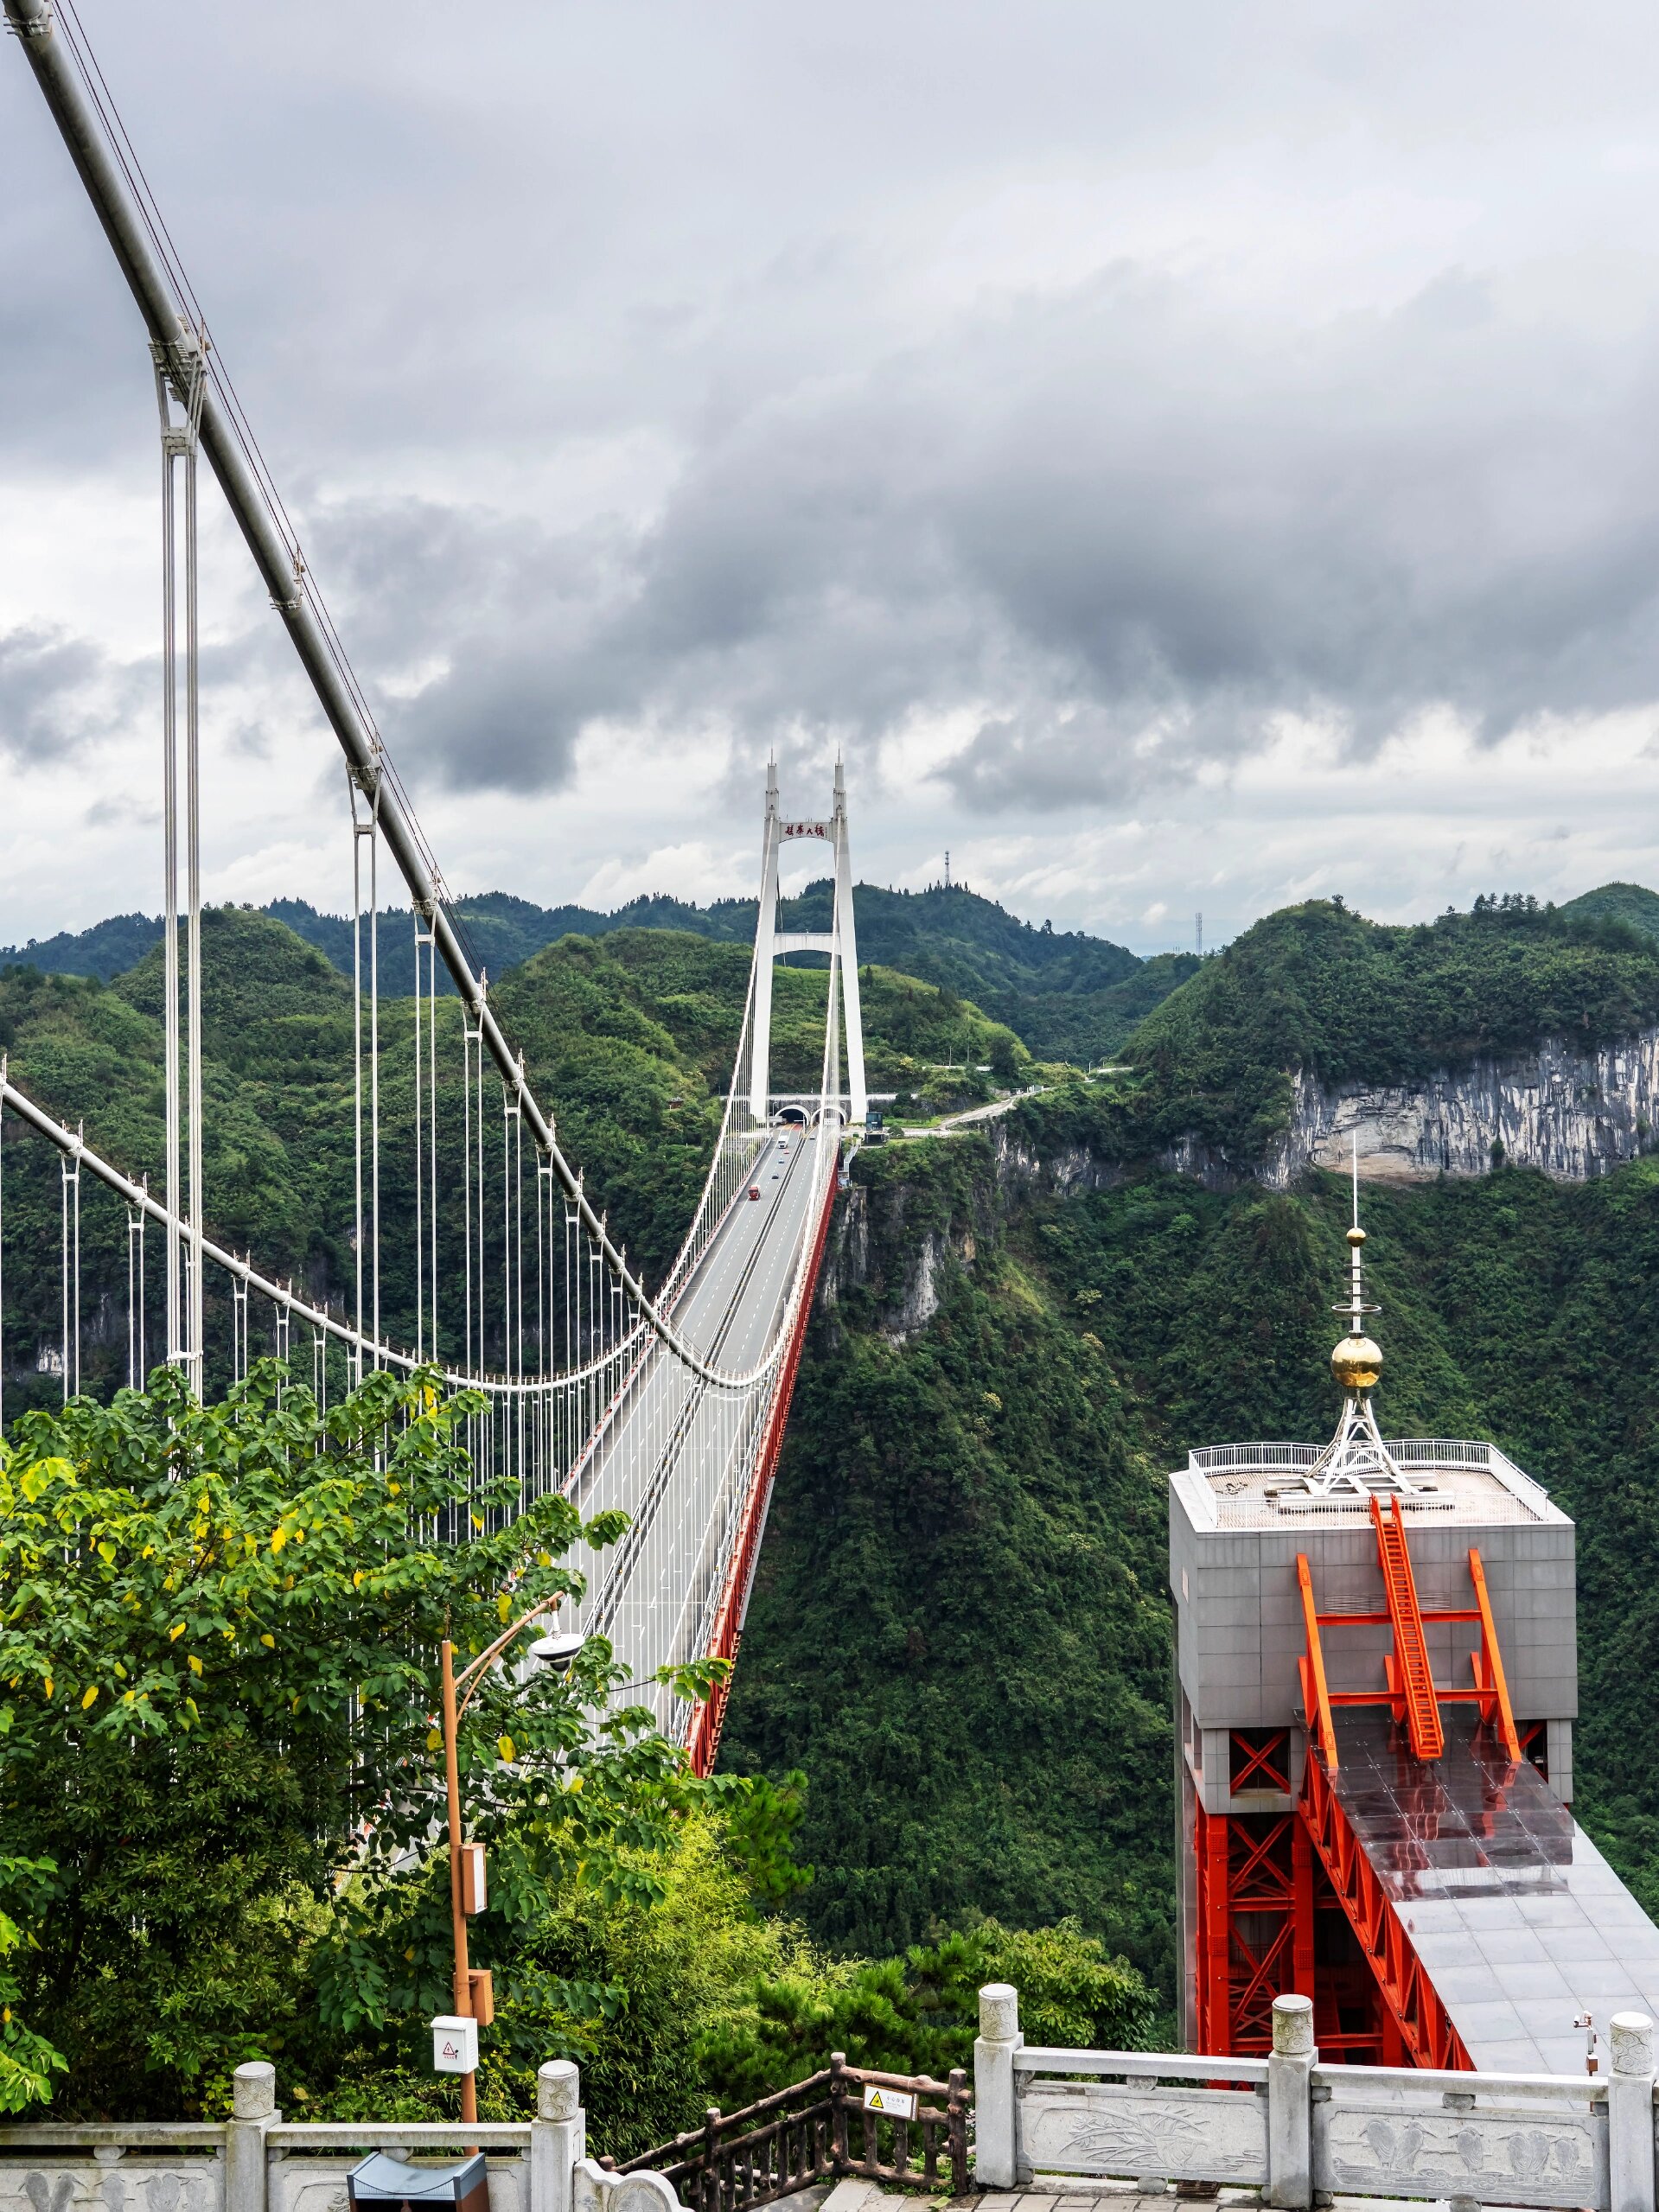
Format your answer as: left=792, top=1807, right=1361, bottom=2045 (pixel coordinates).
left=0, top=0, right=867, bottom=1772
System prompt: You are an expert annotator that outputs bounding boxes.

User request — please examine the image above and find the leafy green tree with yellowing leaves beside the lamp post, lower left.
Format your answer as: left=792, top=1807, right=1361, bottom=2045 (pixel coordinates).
left=0, top=1362, right=717, bottom=2113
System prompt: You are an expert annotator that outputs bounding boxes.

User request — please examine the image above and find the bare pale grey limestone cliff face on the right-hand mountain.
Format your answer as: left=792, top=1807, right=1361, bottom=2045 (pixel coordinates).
left=1256, top=1030, right=1659, bottom=1190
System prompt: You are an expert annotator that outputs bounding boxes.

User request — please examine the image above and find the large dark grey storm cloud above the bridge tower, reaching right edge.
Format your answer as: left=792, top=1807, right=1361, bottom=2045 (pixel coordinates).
left=303, top=270, right=1659, bottom=812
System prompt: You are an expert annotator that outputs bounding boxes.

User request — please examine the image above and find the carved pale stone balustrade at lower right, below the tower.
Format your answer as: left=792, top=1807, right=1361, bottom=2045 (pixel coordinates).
left=973, top=1982, right=1655, bottom=2212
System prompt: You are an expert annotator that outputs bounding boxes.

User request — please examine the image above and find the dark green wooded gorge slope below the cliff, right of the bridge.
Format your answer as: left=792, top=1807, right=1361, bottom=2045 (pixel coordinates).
left=724, top=1126, right=1659, bottom=1999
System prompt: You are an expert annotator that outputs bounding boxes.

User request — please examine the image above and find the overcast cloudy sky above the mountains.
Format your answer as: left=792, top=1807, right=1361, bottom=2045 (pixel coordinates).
left=0, top=0, right=1659, bottom=949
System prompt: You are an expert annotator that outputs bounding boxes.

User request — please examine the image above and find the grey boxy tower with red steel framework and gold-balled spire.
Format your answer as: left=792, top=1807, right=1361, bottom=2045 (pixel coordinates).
left=1171, top=1179, right=1659, bottom=2073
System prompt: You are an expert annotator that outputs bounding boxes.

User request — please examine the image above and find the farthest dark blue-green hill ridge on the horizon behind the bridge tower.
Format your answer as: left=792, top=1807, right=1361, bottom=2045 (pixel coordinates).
left=0, top=878, right=1196, bottom=1061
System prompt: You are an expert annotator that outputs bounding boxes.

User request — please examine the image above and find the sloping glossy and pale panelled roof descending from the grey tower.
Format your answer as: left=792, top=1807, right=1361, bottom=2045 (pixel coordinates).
left=1331, top=1712, right=1659, bottom=2073
